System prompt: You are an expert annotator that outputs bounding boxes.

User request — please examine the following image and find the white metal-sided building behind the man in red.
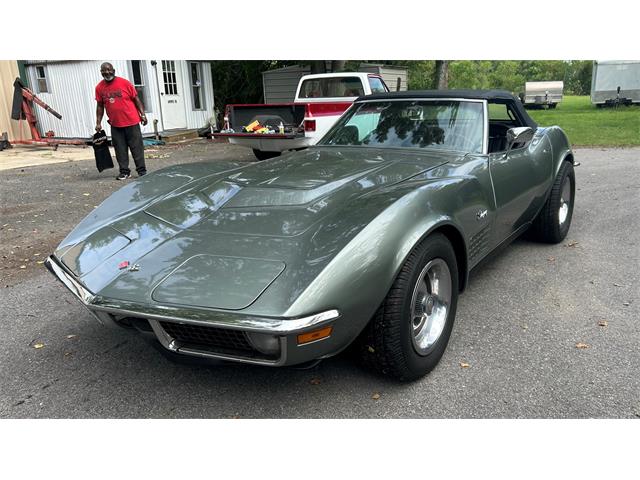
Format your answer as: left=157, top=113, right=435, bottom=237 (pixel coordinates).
left=25, top=59, right=215, bottom=138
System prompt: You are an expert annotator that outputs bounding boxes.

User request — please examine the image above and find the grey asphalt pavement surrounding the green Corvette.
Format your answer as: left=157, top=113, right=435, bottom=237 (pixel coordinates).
left=0, top=142, right=640, bottom=418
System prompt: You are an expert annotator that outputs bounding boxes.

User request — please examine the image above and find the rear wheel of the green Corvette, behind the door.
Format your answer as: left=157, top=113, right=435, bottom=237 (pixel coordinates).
left=530, top=161, right=576, bottom=243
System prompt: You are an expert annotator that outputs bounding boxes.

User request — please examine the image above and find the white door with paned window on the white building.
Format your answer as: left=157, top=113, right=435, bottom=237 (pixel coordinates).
left=158, top=60, right=187, bottom=130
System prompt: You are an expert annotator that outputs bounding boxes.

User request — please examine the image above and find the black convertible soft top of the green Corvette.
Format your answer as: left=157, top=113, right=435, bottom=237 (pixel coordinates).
left=356, top=90, right=538, bottom=130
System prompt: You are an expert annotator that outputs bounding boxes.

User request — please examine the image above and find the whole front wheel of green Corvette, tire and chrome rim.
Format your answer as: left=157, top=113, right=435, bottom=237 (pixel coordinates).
left=356, top=233, right=458, bottom=381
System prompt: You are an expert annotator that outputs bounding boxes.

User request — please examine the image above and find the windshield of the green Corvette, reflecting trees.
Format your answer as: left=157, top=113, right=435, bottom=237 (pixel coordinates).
left=318, top=100, right=484, bottom=153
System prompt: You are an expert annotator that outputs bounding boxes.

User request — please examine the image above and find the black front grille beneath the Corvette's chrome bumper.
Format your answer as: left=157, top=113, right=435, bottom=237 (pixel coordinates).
left=160, top=321, right=264, bottom=358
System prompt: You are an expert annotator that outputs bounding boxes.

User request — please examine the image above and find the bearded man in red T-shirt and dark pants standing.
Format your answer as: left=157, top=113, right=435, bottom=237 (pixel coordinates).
left=96, top=62, right=147, bottom=180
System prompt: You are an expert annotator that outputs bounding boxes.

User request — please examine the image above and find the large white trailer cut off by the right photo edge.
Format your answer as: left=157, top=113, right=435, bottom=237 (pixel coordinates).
left=591, top=60, right=640, bottom=107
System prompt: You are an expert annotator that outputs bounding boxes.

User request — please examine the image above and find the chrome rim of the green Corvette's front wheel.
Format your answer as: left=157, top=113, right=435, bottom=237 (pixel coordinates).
left=411, top=258, right=452, bottom=355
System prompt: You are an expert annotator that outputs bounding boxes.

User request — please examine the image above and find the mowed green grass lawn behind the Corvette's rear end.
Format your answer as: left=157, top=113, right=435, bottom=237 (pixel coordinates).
left=528, top=95, right=640, bottom=147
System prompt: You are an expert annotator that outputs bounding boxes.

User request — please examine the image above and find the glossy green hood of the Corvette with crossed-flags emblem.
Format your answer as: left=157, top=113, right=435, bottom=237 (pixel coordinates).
left=56, top=147, right=460, bottom=314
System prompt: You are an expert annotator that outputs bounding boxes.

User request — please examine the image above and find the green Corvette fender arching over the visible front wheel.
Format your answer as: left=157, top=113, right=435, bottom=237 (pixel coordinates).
left=286, top=177, right=493, bottom=344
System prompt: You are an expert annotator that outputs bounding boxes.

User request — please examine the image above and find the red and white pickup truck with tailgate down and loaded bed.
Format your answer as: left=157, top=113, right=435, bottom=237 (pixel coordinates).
left=213, top=72, right=389, bottom=160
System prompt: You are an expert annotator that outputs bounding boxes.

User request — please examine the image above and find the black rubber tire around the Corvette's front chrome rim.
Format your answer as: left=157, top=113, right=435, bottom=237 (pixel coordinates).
left=355, top=233, right=459, bottom=381
